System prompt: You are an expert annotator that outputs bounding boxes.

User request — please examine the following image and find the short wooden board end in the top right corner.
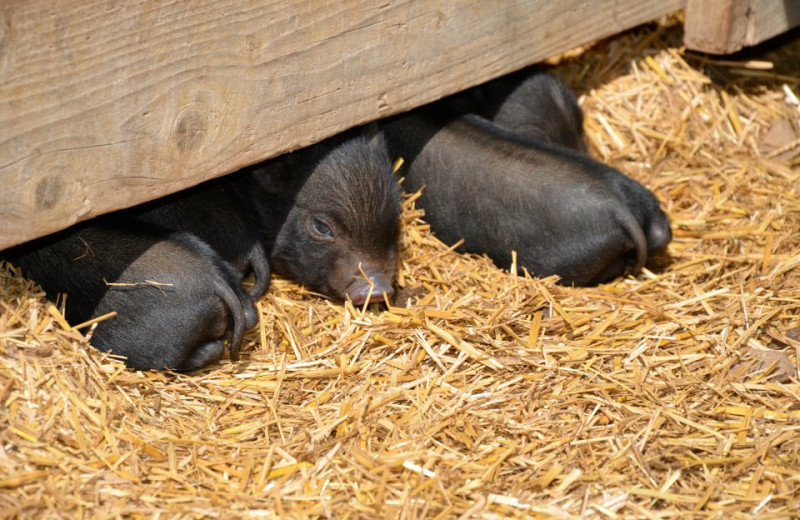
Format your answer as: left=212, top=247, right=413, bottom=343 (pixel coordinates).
left=684, top=0, right=800, bottom=54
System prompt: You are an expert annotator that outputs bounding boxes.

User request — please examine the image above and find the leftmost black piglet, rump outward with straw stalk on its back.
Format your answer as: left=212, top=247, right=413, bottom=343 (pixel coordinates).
left=4, top=219, right=258, bottom=370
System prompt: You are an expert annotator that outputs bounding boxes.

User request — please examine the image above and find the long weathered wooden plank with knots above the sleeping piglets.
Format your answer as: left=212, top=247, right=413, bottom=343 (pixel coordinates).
left=0, top=0, right=685, bottom=249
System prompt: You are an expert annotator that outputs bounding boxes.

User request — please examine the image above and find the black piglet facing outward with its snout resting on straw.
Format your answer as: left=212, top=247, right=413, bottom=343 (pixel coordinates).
left=236, top=127, right=400, bottom=304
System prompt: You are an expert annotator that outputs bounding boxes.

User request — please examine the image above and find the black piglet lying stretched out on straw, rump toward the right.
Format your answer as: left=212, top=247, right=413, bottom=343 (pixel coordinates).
left=384, top=111, right=660, bottom=285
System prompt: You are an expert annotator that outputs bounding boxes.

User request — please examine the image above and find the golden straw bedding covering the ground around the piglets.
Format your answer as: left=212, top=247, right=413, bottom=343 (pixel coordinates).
left=0, top=14, right=800, bottom=519
